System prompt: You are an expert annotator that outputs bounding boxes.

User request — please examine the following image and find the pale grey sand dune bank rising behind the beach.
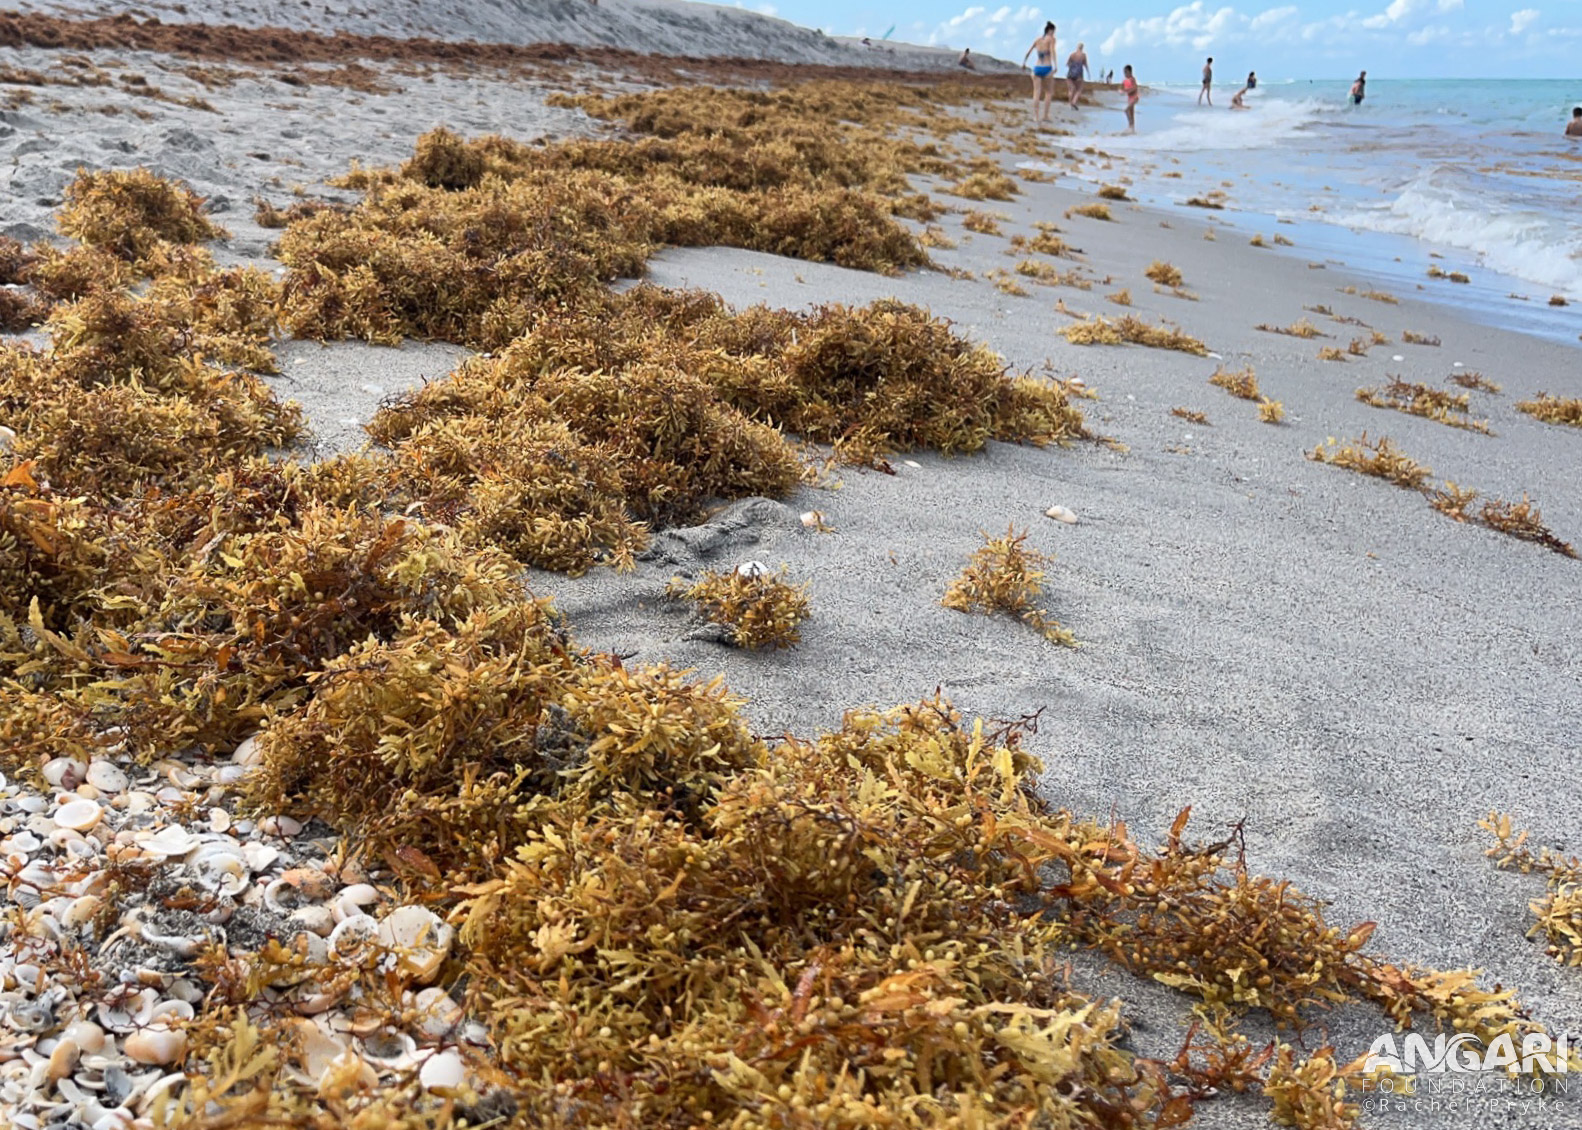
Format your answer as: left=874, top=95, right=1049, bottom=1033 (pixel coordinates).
left=17, top=0, right=1006, bottom=70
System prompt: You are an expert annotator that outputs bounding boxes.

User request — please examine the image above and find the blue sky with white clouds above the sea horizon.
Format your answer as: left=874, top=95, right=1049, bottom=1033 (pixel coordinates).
left=739, top=0, right=1582, bottom=77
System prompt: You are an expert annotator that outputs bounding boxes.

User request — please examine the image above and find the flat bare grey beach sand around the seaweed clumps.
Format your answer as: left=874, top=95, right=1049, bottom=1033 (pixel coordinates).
left=9, top=5, right=1582, bottom=1127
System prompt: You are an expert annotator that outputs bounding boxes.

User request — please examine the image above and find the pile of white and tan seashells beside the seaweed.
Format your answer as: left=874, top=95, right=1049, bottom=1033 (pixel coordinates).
left=0, top=739, right=484, bottom=1130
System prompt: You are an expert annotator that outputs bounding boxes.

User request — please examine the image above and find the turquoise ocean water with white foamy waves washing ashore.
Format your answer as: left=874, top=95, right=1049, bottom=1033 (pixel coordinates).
left=1037, top=79, right=1582, bottom=342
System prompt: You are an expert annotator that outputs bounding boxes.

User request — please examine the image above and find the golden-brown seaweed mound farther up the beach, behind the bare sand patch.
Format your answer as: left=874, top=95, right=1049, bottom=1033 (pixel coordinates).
left=278, top=84, right=987, bottom=348
